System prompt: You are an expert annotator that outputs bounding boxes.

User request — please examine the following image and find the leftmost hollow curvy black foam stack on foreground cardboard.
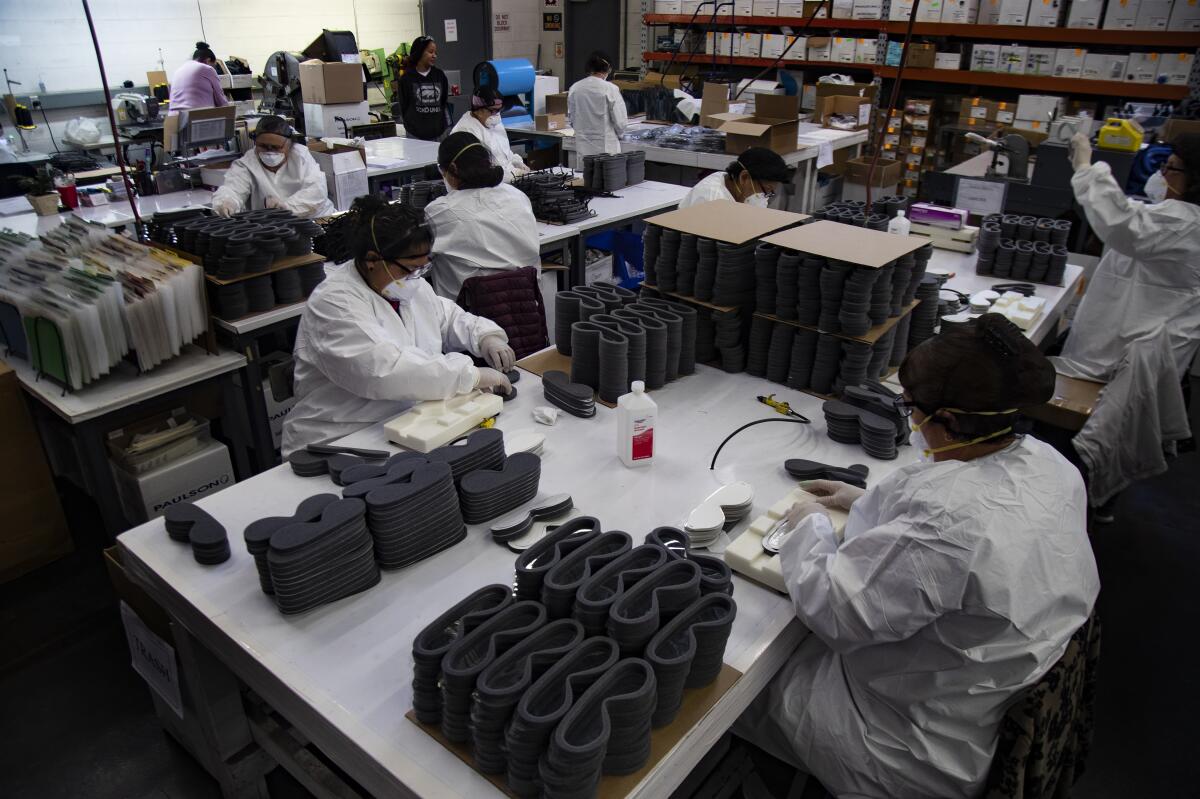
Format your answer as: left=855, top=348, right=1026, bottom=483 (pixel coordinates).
left=413, top=584, right=512, bottom=725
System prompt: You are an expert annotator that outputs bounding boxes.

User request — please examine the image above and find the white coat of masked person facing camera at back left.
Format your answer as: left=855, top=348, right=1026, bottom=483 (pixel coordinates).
left=212, top=143, right=337, bottom=220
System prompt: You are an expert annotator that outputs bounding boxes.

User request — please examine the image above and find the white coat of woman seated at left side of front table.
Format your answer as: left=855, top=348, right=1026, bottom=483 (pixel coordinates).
left=283, top=262, right=508, bottom=456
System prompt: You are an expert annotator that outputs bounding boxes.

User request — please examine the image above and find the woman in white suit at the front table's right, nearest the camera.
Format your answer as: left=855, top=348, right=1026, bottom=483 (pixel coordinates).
left=734, top=314, right=1099, bottom=799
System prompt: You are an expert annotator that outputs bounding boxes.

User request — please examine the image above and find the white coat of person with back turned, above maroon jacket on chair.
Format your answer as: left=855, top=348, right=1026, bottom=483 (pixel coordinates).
left=425, top=184, right=541, bottom=301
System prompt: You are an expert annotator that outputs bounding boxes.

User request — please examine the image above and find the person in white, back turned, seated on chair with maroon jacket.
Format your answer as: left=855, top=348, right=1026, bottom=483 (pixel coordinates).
left=425, top=132, right=541, bottom=300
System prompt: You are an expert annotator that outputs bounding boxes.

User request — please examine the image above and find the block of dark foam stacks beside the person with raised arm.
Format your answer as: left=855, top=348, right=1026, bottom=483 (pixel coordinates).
left=976, top=214, right=1070, bottom=286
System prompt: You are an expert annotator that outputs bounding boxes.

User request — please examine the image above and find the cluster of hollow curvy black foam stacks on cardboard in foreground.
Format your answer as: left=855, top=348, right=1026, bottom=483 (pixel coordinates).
left=413, top=517, right=737, bottom=798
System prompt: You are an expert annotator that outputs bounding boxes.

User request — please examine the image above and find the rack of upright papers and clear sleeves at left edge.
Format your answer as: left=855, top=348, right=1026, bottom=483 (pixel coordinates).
left=0, top=218, right=214, bottom=390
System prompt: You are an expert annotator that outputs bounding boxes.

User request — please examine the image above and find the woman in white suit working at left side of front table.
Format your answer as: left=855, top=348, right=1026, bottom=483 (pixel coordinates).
left=283, top=194, right=516, bottom=455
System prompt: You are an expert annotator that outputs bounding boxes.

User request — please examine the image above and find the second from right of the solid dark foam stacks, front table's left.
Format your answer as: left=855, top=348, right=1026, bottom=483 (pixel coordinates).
left=366, top=456, right=465, bottom=569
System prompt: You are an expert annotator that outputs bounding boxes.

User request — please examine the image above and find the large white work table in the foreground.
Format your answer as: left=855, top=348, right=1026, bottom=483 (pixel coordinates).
left=119, top=366, right=912, bottom=799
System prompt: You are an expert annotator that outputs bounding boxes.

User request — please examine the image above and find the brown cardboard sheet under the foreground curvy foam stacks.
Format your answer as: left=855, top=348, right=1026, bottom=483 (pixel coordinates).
left=404, top=663, right=742, bottom=799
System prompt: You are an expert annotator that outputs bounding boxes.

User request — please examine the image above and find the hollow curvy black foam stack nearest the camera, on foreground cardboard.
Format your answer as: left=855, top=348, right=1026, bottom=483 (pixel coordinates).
left=538, top=657, right=658, bottom=799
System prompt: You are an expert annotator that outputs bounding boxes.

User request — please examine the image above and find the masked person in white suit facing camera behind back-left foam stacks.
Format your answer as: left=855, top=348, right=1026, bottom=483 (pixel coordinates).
left=212, top=116, right=337, bottom=220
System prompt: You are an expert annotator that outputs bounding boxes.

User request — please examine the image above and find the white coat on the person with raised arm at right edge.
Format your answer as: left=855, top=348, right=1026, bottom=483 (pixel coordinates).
left=1062, top=162, right=1200, bottom=380
